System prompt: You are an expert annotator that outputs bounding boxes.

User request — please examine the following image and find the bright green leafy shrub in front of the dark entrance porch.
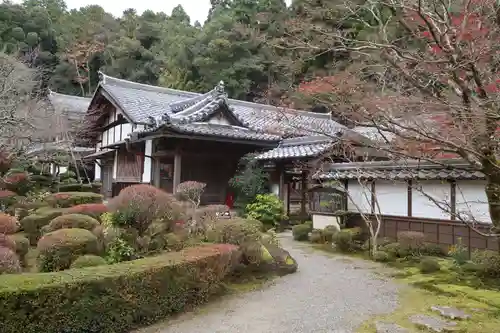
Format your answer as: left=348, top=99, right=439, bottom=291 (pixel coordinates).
left=246, top=194, right=286, bottom=230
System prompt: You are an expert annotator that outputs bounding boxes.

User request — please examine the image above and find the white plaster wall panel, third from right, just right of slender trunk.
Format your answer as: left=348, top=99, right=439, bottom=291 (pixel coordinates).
left=375, top=180, right=408, bottom=216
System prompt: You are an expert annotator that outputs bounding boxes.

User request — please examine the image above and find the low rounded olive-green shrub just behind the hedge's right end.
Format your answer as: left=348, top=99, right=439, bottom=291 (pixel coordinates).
left=206, top=219, right=261, bottom=245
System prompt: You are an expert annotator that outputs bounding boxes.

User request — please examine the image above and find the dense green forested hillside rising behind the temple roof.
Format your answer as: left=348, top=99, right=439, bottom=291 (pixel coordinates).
left=0, top=0, right=346, bottom=108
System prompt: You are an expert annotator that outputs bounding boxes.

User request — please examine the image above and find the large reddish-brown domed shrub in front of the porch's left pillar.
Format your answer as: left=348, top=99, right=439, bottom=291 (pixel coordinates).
left=107, top=184, right=184, bottom=236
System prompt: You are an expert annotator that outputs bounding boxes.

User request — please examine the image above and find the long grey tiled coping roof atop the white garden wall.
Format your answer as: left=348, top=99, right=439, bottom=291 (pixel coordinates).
left=315, top=161, right=484, bottom=180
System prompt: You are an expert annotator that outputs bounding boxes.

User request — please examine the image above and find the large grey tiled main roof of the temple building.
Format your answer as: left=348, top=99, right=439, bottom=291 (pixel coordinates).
left=95, top=73, right=347, bottom=136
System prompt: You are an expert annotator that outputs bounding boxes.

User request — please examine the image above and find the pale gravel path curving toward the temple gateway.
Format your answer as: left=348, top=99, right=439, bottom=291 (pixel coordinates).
left=140, top=234, right=397, bottom=333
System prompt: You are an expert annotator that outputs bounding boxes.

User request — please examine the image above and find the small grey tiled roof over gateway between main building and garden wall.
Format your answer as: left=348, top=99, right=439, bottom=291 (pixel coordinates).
left=256, top=136, right=333, bottom=160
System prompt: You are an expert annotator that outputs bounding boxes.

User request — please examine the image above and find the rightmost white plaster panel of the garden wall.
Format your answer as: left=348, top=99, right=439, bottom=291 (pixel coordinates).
left=456, top=180, right=491, bottom=223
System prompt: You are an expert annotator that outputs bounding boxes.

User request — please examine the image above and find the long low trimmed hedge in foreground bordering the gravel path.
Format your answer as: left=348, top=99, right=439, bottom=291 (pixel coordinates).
left=0, top=244, right=240, bottom=333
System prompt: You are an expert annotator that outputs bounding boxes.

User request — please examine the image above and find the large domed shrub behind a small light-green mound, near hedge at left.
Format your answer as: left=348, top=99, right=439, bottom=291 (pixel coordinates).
left=37, top=228, right=100, bottom=272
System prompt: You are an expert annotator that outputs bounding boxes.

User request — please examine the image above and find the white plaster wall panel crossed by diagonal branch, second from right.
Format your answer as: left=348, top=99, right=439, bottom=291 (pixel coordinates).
left=412, top=180, right=451, bottom=220
